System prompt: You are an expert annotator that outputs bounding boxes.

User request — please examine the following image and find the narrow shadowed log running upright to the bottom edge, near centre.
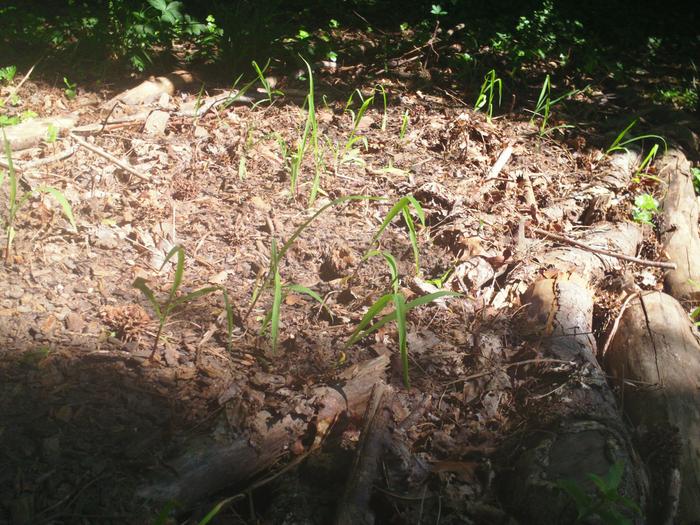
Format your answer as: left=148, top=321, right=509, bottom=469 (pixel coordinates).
left=335, top=382, right=393, bottom=525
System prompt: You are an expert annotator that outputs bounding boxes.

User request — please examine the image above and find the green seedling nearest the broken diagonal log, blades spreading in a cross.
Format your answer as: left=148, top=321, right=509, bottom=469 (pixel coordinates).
left=345, top=250, right=460, bottom=388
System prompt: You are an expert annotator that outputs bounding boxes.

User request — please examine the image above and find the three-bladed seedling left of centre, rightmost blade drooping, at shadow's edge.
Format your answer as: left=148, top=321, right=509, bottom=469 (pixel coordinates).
left=132, top=245, right=233, bottom=359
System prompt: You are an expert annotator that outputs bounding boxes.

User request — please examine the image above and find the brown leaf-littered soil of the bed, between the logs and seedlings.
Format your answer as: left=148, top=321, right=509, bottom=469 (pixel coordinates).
left=0, top=51, right=697, bottom=524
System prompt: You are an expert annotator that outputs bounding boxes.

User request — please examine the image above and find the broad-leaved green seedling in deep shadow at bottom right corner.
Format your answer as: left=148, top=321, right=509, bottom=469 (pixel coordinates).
left=557, top=461, right=642, bottom=525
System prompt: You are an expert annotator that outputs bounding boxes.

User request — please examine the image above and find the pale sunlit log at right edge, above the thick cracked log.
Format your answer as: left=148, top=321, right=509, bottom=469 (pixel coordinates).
left=657, top=150, right=700, bottom=302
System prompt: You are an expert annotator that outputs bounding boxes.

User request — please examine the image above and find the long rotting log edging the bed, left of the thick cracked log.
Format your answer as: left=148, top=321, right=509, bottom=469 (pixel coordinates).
left=501, top=225, right=648, bottom=524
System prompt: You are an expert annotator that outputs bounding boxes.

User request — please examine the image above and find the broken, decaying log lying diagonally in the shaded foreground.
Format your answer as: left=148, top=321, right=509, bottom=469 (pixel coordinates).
left=139, top=355, right=389, bottom=507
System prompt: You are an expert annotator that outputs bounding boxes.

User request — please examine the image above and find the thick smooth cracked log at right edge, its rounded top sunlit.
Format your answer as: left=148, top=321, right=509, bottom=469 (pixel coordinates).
left=605, top=292, right=700, bottom=523
